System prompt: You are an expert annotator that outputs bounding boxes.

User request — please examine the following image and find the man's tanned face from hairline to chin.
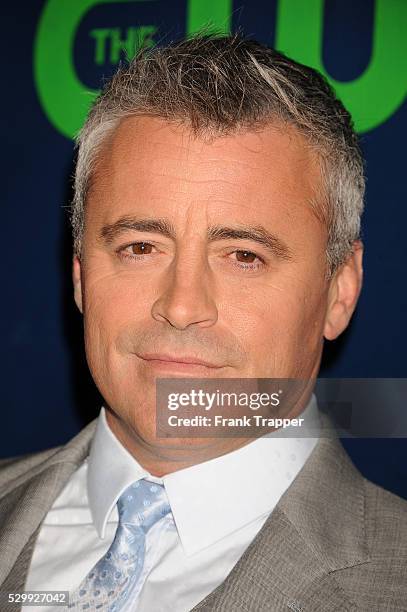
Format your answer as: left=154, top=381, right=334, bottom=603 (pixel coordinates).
left=74, top=117, right=364, bottom=460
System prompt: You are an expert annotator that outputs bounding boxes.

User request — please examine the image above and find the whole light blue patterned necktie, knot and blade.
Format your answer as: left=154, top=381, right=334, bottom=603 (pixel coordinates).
left=68, top=479, right=171, bottom=612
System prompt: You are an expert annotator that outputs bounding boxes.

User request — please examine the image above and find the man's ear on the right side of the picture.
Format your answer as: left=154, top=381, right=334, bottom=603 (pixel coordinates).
left=324, top=240, right=363, bottom=340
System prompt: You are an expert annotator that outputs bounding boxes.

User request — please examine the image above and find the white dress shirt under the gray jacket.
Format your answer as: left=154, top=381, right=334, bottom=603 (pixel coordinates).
left=25, top=395, right=319, bottom=612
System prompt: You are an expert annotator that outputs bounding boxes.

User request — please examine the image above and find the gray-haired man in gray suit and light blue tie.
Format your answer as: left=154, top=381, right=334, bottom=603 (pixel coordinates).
left=0, top=35, right=407, bottom=612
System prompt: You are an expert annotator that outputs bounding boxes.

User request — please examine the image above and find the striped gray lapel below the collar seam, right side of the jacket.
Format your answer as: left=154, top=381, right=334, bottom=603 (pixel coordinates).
left=193, top=508, right=356, bottom=612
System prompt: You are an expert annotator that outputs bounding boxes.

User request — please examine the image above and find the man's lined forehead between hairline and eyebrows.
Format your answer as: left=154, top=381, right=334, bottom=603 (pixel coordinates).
left=89, top=117, right=321, bottom=227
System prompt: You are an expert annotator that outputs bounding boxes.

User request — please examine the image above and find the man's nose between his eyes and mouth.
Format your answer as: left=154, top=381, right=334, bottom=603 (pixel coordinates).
left=151, top=252, right=218, bottom=330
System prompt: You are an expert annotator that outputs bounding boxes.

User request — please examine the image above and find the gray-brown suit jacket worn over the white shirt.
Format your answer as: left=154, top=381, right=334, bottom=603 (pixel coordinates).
left=0, top=419, right=407, bottom=612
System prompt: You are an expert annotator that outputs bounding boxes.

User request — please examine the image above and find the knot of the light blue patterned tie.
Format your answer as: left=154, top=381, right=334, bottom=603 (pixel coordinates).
left=117, top=478, right=171, bottom=532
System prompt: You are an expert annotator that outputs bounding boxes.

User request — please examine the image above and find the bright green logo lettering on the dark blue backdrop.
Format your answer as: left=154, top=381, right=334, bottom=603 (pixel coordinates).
left=34, top=0, right=407, bottom=138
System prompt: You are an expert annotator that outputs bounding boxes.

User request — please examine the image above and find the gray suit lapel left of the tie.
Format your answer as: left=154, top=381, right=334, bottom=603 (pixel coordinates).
left=0, top=419, right=97, bottom=592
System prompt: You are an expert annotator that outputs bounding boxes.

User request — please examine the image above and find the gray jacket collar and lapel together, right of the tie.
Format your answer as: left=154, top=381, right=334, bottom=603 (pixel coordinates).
left=193, top=428, right=369, bottom=612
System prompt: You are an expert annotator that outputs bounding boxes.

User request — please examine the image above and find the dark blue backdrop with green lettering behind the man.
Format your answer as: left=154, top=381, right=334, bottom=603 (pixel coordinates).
left=0, top=0, right=407, bottom=498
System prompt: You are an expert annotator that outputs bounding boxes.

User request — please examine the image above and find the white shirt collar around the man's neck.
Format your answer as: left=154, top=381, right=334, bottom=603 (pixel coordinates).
left=87, top=394, right=319, bottom=555
